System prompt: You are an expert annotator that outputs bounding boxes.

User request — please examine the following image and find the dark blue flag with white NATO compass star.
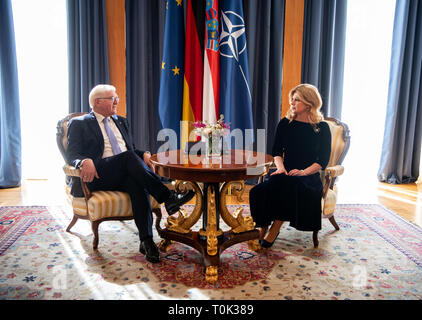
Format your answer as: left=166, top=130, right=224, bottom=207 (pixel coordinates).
left=220, top=0, right=253, bottom=146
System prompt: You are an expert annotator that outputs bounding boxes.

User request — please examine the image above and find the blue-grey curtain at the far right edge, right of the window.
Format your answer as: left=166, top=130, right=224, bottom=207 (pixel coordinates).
left=378, top=0, right=422, bottom=184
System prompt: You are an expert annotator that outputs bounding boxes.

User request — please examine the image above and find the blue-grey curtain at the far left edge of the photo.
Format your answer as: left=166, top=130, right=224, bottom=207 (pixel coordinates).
left=0, top=0, right=22, bottom=188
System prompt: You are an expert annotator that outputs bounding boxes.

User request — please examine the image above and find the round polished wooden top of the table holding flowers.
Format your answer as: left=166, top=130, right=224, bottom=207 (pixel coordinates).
left=151, top=150, right=273, bottom=182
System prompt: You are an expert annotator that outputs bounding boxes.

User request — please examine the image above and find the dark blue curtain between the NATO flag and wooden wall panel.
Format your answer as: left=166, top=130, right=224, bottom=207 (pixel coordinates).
left=243, top=0, right=285, bottom=152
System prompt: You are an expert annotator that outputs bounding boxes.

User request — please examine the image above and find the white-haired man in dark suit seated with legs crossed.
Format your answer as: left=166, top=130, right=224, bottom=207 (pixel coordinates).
left=66, top=85, right=194, bottom=263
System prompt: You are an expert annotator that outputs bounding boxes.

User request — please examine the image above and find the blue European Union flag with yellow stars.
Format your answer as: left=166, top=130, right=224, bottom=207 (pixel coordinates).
left=158, top=0, right=185, bottom=148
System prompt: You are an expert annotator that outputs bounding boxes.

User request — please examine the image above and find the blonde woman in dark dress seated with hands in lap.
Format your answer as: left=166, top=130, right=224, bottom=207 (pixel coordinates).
left=249, top=84, right=331, bottom=248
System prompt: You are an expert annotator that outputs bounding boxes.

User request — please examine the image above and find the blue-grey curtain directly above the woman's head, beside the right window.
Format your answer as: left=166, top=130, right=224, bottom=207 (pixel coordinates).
left=302, top=0, right=347, bottom=119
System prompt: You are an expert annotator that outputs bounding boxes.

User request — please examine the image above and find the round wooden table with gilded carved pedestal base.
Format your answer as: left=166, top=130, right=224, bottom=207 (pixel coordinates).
left=151, top=150, right=273, bottom=283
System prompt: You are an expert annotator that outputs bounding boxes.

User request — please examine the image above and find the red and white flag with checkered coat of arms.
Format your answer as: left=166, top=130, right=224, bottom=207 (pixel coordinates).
left=202, top=0, right=220, bottom=123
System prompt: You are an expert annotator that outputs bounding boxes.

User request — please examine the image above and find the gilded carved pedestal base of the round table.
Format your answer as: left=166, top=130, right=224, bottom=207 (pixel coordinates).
left=154, top=181, right=260, bottom=283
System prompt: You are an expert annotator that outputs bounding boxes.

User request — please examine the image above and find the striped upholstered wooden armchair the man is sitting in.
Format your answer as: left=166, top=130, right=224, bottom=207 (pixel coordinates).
left=56, top=113, right=161, bottom=249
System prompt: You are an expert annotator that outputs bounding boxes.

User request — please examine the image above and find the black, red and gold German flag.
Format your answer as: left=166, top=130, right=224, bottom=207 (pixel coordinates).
left=181, top=0, right=205, bottom=149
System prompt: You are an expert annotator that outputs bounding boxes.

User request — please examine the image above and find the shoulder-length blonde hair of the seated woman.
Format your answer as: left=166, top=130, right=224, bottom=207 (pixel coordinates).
left=286, top=83, right=324, bottom=128
